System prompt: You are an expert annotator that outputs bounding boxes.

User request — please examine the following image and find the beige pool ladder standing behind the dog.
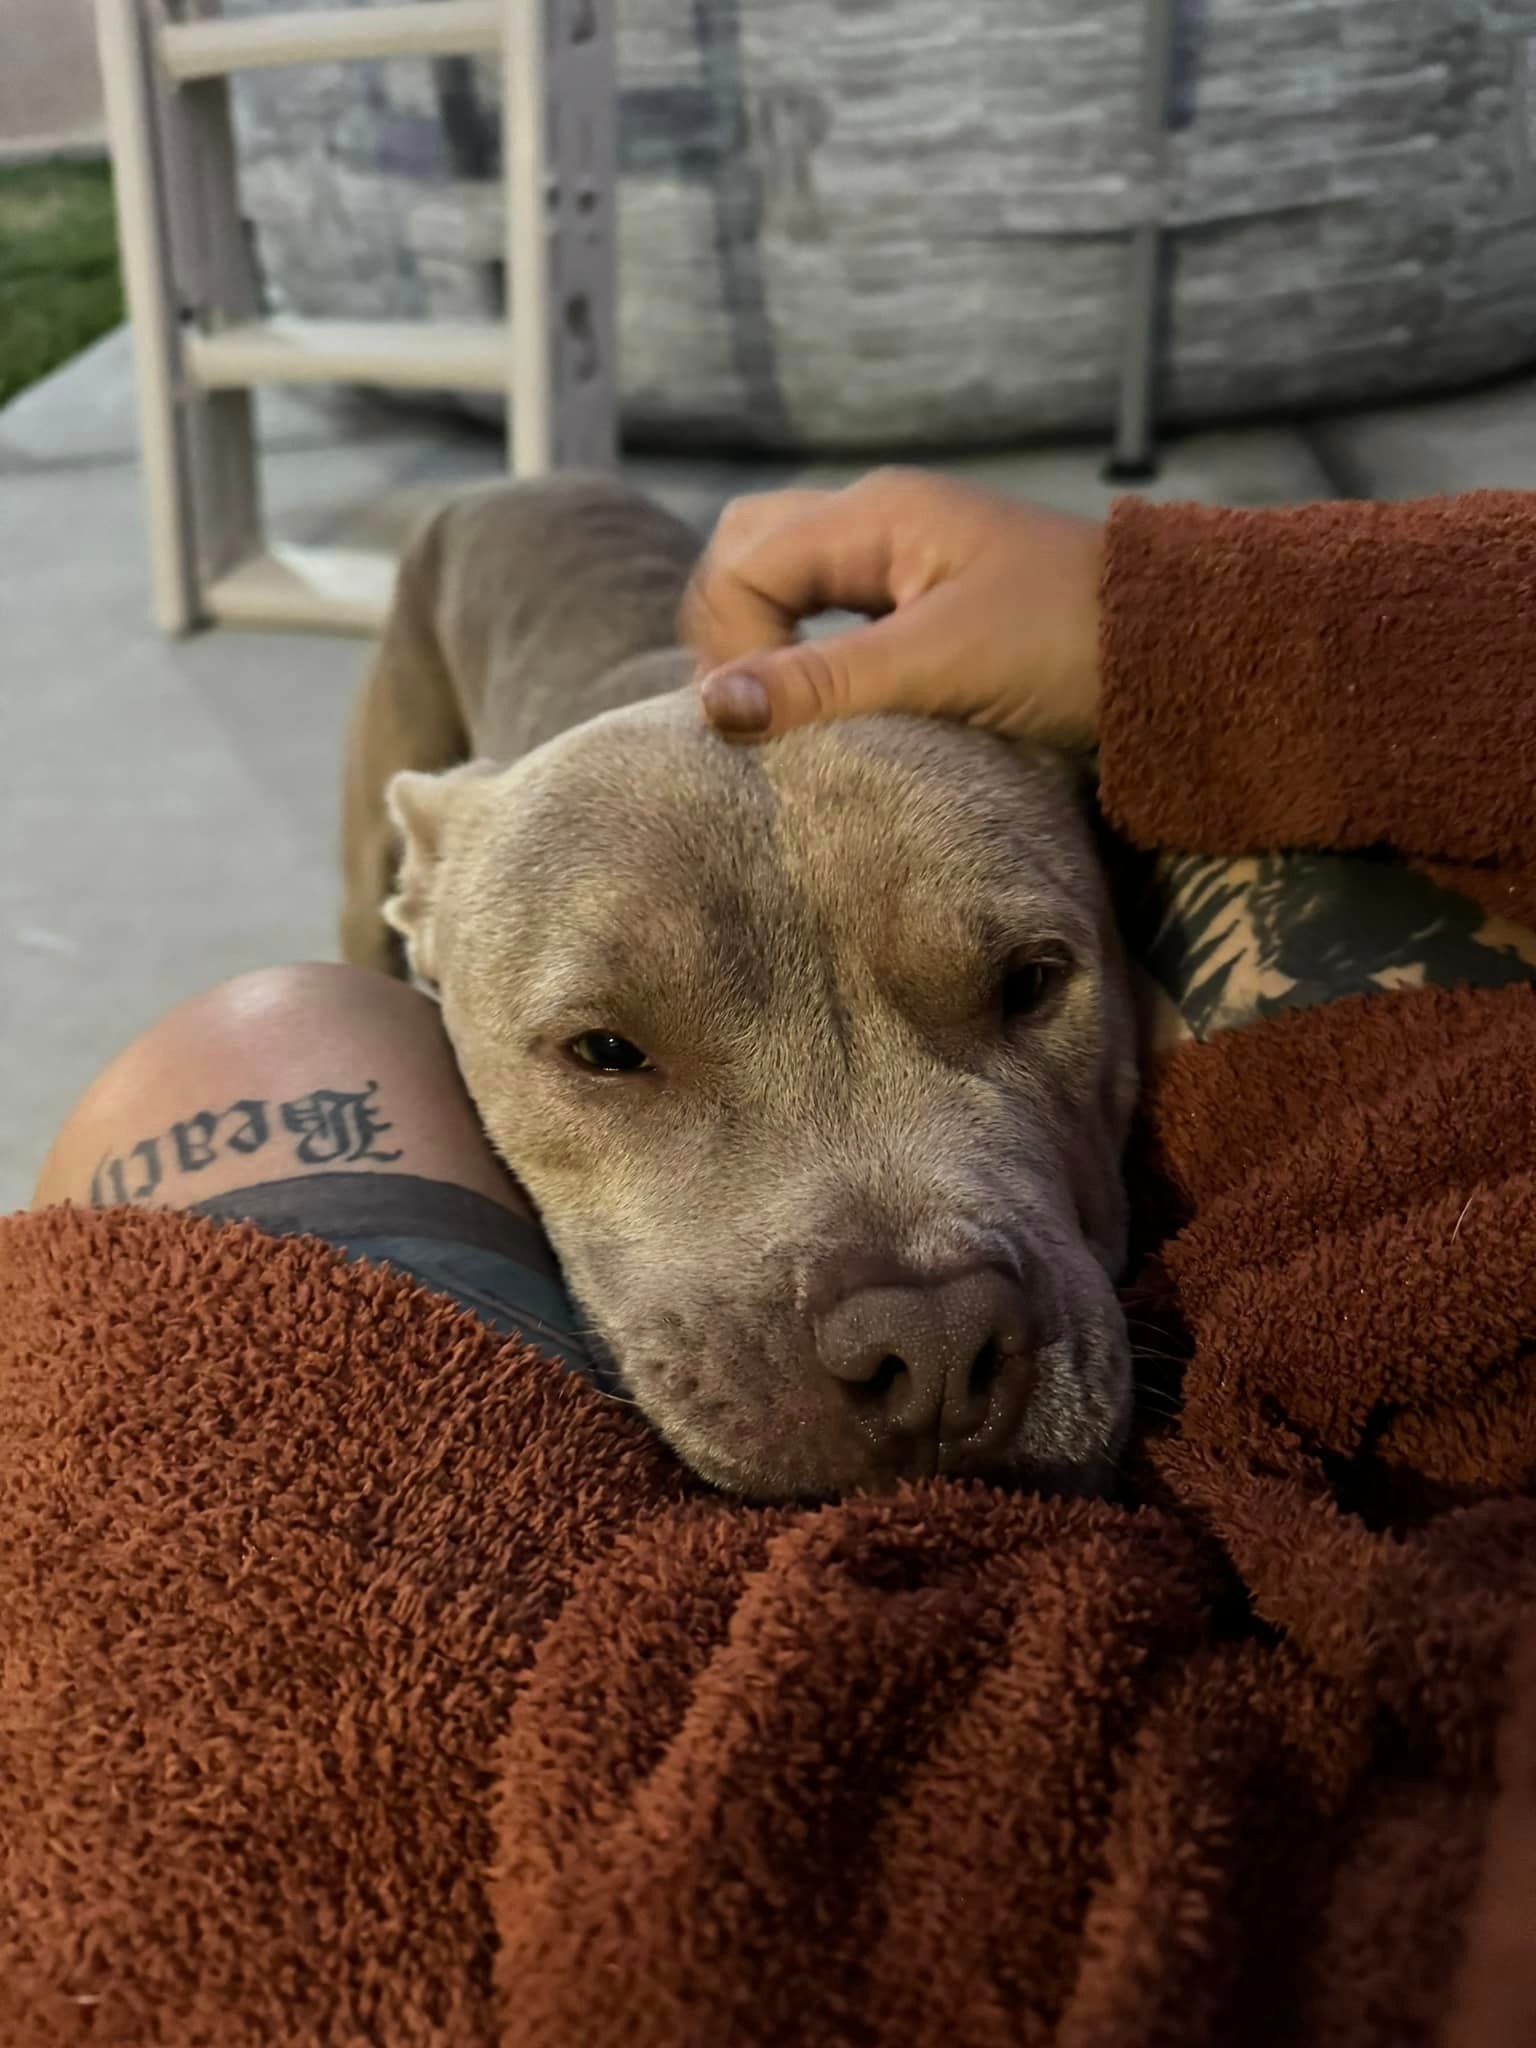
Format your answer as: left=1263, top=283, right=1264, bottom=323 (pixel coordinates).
left=96, top=0, right=618, bottom=633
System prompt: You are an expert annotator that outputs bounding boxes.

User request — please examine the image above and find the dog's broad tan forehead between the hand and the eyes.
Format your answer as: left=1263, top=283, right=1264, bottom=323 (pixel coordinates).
left=450, top=700, right=1098, bottom=991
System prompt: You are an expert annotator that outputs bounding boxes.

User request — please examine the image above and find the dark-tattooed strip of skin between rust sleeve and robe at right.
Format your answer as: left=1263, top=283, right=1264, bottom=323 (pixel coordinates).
left=1122, top=852, right=1536, bottom=1047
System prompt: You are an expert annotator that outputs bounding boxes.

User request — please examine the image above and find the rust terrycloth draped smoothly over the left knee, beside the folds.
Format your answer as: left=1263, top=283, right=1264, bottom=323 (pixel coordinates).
left=0, top=1210, right=682, bottom=2048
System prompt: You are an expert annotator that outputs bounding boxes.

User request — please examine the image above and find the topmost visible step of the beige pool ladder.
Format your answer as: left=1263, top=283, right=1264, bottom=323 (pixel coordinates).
left=160, top=0, right=502, bottom=80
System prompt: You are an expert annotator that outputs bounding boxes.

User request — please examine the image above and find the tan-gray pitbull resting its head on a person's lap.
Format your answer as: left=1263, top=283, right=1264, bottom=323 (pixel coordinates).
left=344, top=479, right=1137, bottom=1499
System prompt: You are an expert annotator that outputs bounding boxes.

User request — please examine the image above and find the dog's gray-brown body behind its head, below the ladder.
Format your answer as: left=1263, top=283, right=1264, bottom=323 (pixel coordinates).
left=340, top=477, right=698, bottom=975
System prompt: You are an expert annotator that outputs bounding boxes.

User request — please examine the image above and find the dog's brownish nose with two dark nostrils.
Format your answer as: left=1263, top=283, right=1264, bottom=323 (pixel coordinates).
left=815, top=1266, right=1032, bottom=1450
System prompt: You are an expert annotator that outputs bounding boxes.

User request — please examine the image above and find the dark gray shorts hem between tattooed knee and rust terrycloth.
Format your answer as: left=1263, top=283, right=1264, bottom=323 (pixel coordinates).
left=190, top=1174, right=606, bottom=1384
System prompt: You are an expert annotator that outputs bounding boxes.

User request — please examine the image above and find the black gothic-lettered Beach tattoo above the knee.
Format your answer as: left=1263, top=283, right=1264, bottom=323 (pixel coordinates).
left=90, top=1081, right=401, bottom=1208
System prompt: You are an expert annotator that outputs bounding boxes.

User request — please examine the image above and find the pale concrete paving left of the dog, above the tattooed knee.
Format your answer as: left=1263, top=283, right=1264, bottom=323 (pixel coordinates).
left=0, top=457, right=365, bottom=1210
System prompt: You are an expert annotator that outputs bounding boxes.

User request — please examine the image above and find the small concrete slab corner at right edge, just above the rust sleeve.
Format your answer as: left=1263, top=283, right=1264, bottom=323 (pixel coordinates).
left=1313, top=377, right=1536, bottom=498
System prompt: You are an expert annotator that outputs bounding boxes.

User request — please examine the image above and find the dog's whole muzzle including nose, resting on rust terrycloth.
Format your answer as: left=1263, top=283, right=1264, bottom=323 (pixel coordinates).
left=565, top=1196, right=1133, bottom=1501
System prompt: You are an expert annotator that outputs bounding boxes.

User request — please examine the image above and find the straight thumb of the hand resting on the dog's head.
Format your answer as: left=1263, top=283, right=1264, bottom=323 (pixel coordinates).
left=698, top=594, right=991, bottom=739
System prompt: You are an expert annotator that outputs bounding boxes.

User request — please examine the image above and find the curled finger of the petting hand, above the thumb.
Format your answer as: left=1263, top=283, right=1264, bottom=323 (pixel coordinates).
left=682, top=492, right=891, bottom=668
